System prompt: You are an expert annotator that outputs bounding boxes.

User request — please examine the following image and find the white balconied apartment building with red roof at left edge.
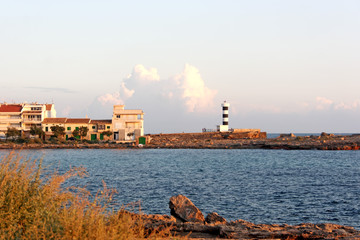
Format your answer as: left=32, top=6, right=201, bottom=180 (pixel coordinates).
left=0, top=103, right=56, bottom=136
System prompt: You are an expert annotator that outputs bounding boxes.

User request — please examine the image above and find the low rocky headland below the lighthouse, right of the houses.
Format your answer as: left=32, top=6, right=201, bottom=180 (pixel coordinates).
left=144, top=132, right=360, bottom=150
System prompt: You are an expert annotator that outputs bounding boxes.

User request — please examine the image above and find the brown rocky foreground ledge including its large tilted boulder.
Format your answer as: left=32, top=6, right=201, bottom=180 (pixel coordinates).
left=142, top=195, right=360, bottom=239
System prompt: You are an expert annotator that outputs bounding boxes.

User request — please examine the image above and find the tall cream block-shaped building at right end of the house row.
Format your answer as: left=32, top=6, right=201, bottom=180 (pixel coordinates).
left=112, top=105, right=144, bottom=141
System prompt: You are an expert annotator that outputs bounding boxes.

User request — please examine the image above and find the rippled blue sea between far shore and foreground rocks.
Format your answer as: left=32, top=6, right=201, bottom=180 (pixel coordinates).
left=0, top=149, right=360, bottom=229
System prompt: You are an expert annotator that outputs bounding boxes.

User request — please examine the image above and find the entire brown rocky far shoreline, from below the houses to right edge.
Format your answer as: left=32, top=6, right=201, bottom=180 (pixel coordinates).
left=0, top=133, right=360, bottom=150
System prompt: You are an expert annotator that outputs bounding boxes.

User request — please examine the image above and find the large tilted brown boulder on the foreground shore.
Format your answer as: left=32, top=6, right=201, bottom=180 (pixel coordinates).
left=169, top=195, right=205, bottom=223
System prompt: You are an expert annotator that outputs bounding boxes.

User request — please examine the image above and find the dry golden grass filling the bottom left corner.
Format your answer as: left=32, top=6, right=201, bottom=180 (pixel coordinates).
left=0, top=152, right=183, bottom=239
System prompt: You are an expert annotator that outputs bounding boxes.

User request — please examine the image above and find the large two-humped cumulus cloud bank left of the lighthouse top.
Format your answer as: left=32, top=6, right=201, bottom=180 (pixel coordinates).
left=97, top=64, right=217, bottom=112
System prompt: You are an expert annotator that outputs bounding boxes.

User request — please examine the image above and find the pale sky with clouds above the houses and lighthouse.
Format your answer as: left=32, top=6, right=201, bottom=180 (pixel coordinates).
left=0, top=0, right=360, bottom=133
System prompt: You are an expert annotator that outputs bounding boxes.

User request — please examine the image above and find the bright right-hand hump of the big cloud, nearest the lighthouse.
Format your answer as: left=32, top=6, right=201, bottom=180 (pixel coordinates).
left=174, top=64, right=217, bottom=112
